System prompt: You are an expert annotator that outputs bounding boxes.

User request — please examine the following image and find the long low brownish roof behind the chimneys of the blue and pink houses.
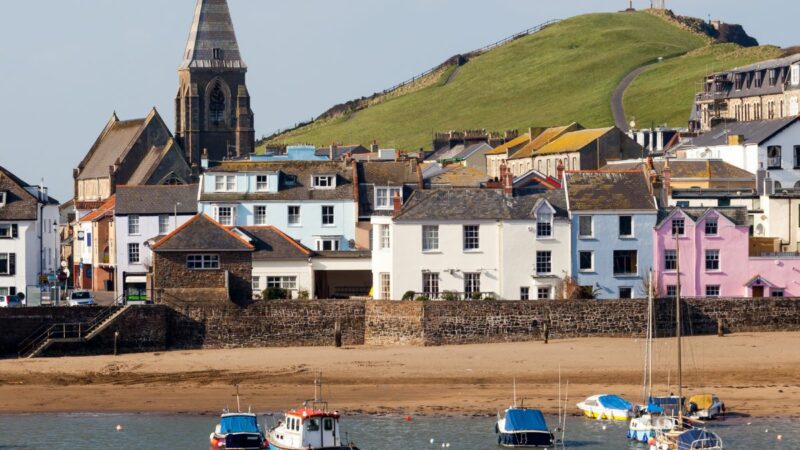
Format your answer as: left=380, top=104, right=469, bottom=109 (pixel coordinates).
left=601, top=159, right=755, bottom=180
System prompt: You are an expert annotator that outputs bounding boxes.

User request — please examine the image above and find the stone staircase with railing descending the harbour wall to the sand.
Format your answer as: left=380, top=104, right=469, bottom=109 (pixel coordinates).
left=18, top=305, right=130, bottom=358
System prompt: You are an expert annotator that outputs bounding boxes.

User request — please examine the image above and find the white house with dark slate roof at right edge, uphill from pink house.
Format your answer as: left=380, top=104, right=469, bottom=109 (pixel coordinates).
left=681, top=116, right=800, bottom=189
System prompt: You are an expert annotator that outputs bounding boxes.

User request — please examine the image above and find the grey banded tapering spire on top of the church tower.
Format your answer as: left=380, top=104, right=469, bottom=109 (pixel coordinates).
left=180, top=0, right=247, bottom=70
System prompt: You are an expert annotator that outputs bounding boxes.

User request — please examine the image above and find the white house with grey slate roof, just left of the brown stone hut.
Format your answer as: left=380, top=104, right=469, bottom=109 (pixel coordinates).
left=113, top=184, right=198, bottom=300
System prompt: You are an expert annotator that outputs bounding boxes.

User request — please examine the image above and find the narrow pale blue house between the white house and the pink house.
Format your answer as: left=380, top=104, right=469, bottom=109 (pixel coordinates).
left=564, top=170, right=658, bottom=299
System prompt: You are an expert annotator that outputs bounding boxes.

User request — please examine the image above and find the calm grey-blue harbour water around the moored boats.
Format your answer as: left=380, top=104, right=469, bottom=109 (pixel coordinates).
left=0, top=414, right=800, bottom=450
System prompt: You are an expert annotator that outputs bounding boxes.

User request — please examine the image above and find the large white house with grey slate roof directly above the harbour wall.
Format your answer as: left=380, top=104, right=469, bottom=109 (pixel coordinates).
left=372, top=184, right=570, bottom=300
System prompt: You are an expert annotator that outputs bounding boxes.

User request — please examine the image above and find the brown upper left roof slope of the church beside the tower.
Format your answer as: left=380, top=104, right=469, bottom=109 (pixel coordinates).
left=78, top=115, right=147, bottom=180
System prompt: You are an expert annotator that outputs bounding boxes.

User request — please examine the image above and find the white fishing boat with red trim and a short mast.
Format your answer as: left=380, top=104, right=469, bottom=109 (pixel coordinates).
left=267, top=375, right=358, bottom=450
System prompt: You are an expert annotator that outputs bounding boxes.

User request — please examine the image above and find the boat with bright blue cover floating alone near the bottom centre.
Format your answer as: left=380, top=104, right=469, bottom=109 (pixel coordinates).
left=495, top=406, right=555, bottom=448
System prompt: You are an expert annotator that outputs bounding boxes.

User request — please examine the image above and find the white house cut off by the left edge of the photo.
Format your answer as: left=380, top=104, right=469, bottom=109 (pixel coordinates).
left=0, top=167, right=60, bottom=304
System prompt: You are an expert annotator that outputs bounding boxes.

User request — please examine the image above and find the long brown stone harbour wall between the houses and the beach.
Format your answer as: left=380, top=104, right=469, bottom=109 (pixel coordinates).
left=0, top=298, right=800, bottom=357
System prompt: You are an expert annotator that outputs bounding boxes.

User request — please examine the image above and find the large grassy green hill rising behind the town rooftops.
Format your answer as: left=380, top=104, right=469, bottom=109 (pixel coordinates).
left=271, top=12, right=780, bottom=149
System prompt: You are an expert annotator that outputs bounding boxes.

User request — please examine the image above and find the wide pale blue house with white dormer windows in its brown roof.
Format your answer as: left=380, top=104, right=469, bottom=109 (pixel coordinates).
left=198, top=161, right=358, bottom=251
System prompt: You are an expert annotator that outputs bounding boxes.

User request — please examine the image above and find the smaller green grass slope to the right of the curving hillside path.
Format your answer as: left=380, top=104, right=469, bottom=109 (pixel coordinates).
left=623, top=44, right=783, bottom=127
